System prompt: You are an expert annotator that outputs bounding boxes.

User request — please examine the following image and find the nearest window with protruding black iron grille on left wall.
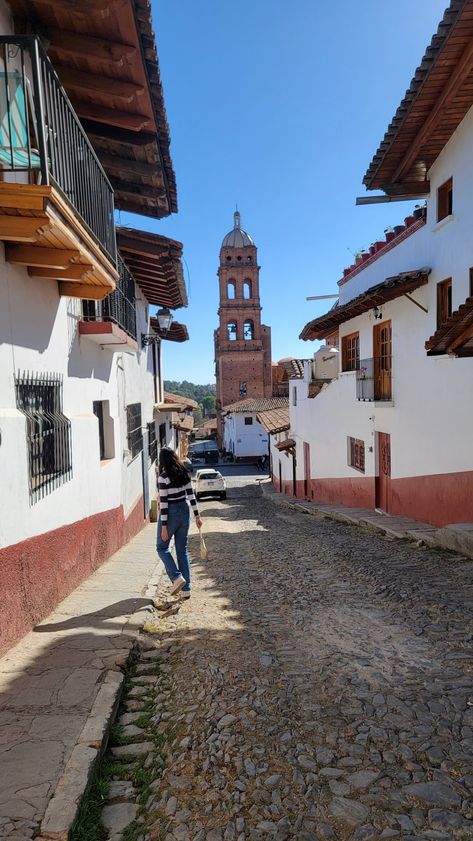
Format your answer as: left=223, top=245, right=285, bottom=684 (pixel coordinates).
left=15, top=373, right=72, bottom=503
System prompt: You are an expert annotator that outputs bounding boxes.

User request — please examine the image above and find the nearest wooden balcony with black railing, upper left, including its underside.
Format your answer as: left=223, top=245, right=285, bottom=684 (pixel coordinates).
left=0, top=36, right=118, bottom=300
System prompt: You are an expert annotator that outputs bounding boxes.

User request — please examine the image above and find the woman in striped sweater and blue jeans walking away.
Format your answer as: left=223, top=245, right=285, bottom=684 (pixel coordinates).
left=156, top=447, right=202, bottom=598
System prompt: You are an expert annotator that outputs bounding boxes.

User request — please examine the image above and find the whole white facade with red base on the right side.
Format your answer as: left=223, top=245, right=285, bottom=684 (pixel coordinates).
left=284, top=26, right=473, bottom=525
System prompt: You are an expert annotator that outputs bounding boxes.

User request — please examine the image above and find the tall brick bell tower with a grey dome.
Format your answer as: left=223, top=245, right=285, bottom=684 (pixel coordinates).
left=214, top=211, right=272, bottom=440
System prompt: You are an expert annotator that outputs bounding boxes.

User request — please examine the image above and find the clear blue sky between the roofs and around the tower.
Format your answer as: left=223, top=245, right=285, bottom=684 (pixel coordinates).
left=121, top=0, right=447, bottom=383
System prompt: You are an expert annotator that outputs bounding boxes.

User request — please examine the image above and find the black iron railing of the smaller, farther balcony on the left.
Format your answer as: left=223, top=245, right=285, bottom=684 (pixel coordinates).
left=82, top=254, right=137, bottom=339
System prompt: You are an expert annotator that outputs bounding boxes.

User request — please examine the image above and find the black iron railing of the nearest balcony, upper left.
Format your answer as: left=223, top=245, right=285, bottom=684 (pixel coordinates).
left=0, top=35, right=116, bottom=263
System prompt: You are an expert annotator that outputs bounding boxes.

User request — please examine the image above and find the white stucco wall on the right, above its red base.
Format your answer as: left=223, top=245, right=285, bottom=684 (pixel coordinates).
left=290, top=102, right=473, bottom=488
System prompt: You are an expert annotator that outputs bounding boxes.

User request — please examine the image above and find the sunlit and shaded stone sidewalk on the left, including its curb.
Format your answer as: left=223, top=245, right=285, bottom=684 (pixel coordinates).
left=0, top=524, right=162, bottom=841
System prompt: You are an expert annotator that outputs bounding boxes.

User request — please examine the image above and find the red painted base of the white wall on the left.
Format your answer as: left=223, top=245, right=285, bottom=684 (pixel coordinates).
left=0, top=498, right=145, bottom=654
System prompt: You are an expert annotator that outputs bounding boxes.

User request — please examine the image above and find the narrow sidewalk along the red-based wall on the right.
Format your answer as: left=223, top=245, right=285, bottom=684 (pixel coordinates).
left=260, top=479, right=473, bottom=558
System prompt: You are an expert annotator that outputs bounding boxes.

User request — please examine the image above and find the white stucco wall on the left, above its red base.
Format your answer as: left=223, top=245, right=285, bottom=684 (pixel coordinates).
left=0, top=246, right=160, bottom=546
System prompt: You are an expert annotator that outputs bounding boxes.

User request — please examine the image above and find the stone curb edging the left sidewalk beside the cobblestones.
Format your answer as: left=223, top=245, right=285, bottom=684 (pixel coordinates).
left=36, top=561, right=164, bottom=841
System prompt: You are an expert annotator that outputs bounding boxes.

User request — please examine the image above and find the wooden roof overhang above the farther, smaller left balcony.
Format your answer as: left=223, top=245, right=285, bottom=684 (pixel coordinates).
left=117, top=228, right=188, bottom=309
